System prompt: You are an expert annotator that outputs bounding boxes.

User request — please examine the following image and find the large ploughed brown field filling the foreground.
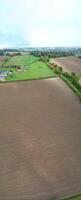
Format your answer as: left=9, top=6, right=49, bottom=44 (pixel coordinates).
left=0, top=78, right=81, bottom=200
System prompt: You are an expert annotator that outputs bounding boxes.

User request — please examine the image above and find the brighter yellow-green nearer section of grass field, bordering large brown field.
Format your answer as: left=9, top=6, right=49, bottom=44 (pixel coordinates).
left=7, top=61, right=55, bottom=81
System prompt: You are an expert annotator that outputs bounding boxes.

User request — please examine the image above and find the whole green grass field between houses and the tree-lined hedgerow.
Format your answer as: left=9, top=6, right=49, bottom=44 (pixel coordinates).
left=0, top=55, right=55, bottom=81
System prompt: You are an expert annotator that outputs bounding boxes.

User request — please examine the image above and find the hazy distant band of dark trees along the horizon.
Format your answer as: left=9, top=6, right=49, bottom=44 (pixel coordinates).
left=0, top=47, right=81, bottom=58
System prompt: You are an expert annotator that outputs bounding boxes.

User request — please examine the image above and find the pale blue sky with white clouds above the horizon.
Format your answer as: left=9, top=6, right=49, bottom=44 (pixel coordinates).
left=0, top=0, right=81, bottom=48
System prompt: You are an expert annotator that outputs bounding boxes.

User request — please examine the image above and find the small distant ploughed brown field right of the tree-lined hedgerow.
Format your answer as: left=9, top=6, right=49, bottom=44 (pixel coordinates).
left=51, top=56, right=81, bottom=75
